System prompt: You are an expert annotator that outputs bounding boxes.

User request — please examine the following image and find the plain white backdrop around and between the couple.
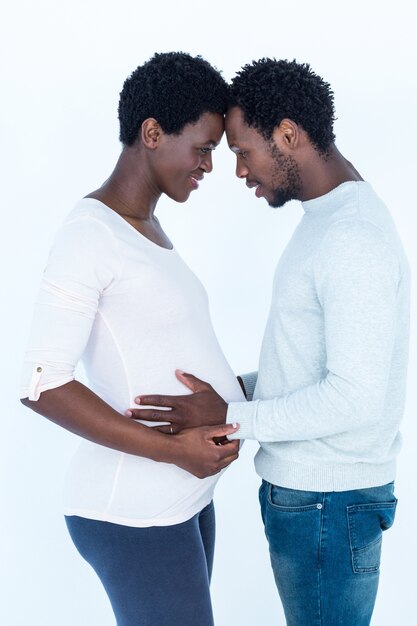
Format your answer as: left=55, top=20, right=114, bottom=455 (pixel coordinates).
left=0, top=0, right=417, bottom=626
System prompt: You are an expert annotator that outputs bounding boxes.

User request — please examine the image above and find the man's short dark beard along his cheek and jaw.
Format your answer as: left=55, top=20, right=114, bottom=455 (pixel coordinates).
left=268, top=143, right=302, bottom=209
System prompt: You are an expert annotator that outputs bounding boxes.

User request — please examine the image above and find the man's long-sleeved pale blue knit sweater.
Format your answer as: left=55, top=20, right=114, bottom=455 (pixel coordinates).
left=227, top=182, right=410, bottom=491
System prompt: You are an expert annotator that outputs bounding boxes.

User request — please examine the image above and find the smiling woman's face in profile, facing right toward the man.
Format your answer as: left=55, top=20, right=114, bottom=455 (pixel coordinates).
left=156, top=113, right=224, bottom=202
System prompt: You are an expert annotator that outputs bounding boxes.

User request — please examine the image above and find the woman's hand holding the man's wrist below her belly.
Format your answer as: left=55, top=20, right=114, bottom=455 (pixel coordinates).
left=165, top=424, right=240, bottom=478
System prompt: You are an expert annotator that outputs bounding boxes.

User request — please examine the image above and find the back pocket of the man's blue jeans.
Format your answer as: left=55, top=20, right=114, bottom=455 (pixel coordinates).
left=347, top=499, right=397, bottom=574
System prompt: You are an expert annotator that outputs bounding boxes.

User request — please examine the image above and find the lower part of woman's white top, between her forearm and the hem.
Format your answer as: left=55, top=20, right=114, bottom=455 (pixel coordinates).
left=64, top=442, right=220, bottom=526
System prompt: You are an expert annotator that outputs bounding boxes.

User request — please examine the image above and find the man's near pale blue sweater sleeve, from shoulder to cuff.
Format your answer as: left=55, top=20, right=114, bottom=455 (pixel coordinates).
left=227, top=221, right=400, bottom=442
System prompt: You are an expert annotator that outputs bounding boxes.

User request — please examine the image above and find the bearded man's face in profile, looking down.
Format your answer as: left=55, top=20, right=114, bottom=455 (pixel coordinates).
left=226, top=107, right=302, bottom=208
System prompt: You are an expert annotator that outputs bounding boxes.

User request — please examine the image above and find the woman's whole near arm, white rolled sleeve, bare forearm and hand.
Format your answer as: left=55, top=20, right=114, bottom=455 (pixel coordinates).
left=20, top=218, right=238, bottom=478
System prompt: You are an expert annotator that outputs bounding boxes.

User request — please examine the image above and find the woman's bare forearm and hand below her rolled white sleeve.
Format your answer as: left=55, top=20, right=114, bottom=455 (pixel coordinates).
left=22, top=380, right=239, bottom=478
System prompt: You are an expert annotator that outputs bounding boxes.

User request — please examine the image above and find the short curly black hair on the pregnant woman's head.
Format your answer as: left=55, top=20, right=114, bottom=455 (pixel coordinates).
left=119, top=52, right=228, bottom=146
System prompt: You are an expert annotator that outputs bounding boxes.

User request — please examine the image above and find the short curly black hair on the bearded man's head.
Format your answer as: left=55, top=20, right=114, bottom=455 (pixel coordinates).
left=229, top=58, right=335, bottom=154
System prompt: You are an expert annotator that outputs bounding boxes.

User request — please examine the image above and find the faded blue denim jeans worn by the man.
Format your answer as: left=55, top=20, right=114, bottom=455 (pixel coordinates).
left=259, top=481, right=397, bottom=626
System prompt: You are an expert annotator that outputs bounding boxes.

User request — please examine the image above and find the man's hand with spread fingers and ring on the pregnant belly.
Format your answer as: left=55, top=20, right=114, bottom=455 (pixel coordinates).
left=125, top=370, right=227, bottom=434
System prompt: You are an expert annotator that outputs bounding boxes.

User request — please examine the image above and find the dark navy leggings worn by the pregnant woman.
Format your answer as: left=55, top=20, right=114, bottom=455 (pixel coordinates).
left=65, top=503, right=215, bottom=626
